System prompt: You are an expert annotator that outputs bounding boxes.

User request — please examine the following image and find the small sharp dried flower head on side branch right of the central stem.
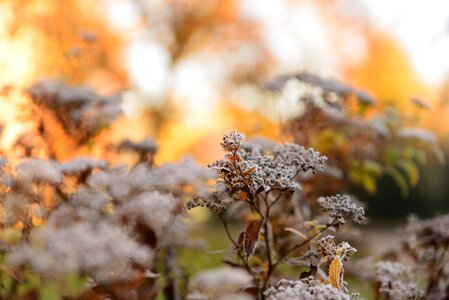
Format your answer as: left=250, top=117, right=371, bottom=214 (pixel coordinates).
left=318, top=194, right=365, bottom=224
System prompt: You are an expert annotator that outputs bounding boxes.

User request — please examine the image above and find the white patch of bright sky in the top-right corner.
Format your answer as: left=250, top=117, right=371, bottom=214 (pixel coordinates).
left=363, top=0, right=449, bottom=84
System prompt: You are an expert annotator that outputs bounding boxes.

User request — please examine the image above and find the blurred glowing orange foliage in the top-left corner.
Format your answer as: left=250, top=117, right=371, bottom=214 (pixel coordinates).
left=0, top=0, right=127, bottom=159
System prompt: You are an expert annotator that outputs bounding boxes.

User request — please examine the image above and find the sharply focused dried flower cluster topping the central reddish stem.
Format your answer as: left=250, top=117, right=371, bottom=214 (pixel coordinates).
left=209, top=131, right=326, bottom=197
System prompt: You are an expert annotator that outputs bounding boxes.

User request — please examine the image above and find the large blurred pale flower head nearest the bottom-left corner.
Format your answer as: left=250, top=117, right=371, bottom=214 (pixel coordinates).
left=8, top=222, right=152, bottom=283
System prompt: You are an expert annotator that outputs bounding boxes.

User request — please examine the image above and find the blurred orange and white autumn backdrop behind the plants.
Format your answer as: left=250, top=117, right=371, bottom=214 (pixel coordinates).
left=0, top=0, right=449, bottom=221
